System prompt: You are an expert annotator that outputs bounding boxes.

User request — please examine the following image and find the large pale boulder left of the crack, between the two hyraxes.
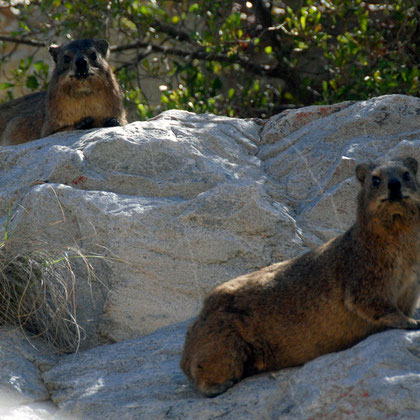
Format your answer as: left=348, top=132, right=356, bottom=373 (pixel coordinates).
left=0, top=111, right=303, bottom=340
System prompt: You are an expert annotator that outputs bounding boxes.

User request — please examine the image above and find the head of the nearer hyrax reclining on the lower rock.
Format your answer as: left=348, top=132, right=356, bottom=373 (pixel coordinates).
left=356, top=157, right=420, bottom=227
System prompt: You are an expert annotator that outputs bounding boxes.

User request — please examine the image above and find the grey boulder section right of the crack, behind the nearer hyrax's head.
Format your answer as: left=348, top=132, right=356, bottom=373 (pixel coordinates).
left=258, top=95, right=420, bottom=244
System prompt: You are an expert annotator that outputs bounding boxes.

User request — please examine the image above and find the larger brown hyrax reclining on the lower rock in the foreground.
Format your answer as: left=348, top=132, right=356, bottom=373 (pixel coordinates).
left=181, top=158, right=420, bottom=397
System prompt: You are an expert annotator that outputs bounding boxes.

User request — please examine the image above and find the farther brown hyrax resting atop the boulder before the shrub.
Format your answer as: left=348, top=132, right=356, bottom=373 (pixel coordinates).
left=0, top=39, right=127, bottom=146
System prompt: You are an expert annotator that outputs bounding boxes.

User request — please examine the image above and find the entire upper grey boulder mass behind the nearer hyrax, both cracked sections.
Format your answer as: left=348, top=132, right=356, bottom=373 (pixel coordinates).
left=0, top=95, right=420, bottom=346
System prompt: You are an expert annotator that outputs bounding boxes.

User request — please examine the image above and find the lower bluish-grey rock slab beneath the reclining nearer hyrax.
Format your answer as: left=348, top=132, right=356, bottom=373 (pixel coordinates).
left=43, top=323, right=420, bottom=420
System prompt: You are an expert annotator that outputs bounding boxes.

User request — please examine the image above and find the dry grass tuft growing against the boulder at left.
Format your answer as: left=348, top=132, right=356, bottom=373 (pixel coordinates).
left=0, top=205, right=103, bottom=352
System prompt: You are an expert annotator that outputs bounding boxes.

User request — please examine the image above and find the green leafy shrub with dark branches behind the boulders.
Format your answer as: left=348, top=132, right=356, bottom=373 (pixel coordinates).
left=0, top=0, right=420, bottom=119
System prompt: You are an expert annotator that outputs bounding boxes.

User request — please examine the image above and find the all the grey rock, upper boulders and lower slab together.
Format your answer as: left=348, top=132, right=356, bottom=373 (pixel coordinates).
left=0, top=95, right=420, bottom=419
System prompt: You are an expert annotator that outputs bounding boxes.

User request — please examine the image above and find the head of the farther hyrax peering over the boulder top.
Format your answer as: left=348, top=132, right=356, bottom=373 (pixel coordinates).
left=49, top=39, right=110, bottom=94
